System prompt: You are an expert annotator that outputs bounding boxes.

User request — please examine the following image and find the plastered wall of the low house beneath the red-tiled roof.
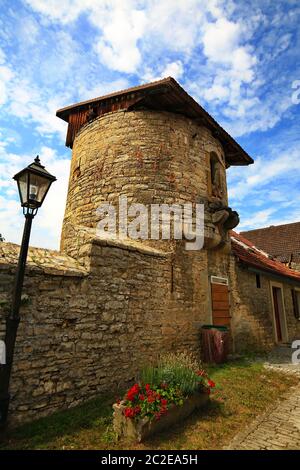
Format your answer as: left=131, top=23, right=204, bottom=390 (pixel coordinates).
left=230, top=256, right=300, bottom=352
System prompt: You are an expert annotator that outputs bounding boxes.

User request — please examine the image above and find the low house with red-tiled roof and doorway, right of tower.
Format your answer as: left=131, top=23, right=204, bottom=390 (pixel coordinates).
left=230, top=232, right=300, bottom=351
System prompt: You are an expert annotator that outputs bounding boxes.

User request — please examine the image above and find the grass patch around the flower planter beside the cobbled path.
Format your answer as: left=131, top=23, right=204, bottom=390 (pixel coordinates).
left=0, top=360, right=298, bottom=450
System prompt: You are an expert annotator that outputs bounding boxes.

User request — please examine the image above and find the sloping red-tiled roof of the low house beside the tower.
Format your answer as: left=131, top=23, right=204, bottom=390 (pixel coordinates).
left=231, top=231, right=300, bottom=282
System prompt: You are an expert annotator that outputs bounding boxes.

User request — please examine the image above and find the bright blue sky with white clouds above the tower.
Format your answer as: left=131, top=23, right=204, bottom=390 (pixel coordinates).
left=0, top=0, right=300, bottom=248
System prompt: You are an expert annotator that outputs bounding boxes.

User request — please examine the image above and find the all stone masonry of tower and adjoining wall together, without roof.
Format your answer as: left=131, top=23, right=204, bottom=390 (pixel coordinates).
left=0, top=110, right=229, bottom=424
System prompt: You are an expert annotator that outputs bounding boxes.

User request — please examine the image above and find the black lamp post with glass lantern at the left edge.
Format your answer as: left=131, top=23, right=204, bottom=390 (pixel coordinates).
left=0, top=156, right=56, bottom=429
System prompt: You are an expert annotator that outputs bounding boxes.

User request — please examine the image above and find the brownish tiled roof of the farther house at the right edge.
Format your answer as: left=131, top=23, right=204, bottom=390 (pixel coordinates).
left=241, top=222, right=300, bottom=271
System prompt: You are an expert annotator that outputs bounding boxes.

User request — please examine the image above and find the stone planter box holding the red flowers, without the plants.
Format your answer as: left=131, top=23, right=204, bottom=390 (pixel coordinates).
left=113, top=393, right=209, bottom=442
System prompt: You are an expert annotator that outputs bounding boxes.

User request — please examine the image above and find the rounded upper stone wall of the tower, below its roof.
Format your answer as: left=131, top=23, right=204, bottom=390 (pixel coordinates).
left=61, top=110, right=227, bottom=254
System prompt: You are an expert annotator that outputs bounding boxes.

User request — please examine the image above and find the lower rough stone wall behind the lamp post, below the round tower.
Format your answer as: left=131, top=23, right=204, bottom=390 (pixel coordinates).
left=0, top=235, right=212, bottom=424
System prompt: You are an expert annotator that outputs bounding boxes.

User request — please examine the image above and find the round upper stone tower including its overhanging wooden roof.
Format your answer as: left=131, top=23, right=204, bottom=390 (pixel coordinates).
left=57, top=78, right=252, bottom=255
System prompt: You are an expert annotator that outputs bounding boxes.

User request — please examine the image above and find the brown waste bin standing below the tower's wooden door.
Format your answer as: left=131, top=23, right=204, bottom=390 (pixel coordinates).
left=201, top=325, right=229, bottom=364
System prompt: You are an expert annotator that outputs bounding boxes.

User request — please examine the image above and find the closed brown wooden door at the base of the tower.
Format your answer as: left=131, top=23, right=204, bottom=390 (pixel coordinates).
left=211, top=284, right=231, bottom=326
